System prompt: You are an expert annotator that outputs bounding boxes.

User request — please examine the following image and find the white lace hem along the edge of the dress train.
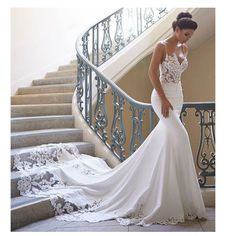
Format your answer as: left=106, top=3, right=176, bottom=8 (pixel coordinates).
left=15, top=144, right=206, bottom=226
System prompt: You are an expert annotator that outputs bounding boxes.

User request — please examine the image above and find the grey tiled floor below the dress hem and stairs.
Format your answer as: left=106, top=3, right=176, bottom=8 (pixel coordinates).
left=14, top=208, right=215, bottom=232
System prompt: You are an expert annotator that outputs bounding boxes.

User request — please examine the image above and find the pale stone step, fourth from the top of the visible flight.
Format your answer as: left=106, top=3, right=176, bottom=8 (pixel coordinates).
left=32, top=76, right=76, bottom=86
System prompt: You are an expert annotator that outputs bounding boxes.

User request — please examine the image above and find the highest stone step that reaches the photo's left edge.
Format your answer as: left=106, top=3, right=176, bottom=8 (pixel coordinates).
left=11, top=93, right=73, bottom=105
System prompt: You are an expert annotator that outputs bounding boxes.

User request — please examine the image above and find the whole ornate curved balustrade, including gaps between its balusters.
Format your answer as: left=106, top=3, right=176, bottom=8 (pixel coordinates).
left=76, top=8, right=215, bottom=187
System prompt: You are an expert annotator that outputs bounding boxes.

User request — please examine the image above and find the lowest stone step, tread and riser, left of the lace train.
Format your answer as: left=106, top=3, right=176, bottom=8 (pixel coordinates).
left=11, top=196, right=55, bottom=230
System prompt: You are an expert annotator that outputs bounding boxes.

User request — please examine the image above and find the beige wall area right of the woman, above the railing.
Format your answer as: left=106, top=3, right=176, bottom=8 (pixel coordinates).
left=182, top=36, right=215, bottom=102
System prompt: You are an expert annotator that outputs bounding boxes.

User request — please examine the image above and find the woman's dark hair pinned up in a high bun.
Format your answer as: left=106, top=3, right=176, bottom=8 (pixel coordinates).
left=172, top=12, right=198, bottom=31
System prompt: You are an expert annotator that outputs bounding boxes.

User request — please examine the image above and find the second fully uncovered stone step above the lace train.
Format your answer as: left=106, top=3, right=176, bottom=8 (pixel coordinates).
left=11, top=115, right=74, bottom=132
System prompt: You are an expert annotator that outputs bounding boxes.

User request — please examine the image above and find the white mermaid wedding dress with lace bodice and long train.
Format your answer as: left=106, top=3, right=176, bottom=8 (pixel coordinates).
left=14, top=40, right=206, bottom=226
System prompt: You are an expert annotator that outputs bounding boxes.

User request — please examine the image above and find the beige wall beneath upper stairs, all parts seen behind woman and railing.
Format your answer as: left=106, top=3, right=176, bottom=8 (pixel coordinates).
left=100, top=36, right=215, bottom=186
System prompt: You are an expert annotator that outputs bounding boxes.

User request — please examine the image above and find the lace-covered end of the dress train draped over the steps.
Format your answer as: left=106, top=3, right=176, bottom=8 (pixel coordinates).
left=12, top=143, right=102, bottom=221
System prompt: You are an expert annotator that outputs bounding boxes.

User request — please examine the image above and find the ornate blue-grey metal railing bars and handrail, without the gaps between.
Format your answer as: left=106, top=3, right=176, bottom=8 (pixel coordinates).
left=75, top=8, right=215, bottom=187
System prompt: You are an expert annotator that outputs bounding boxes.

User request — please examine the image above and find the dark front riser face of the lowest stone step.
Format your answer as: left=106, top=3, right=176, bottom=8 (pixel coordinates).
left=11, top=199, right=55, bottom=230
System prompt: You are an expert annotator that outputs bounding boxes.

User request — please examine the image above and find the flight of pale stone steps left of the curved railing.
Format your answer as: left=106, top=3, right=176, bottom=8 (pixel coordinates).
left=11, top=61, right=101, bottom=230
